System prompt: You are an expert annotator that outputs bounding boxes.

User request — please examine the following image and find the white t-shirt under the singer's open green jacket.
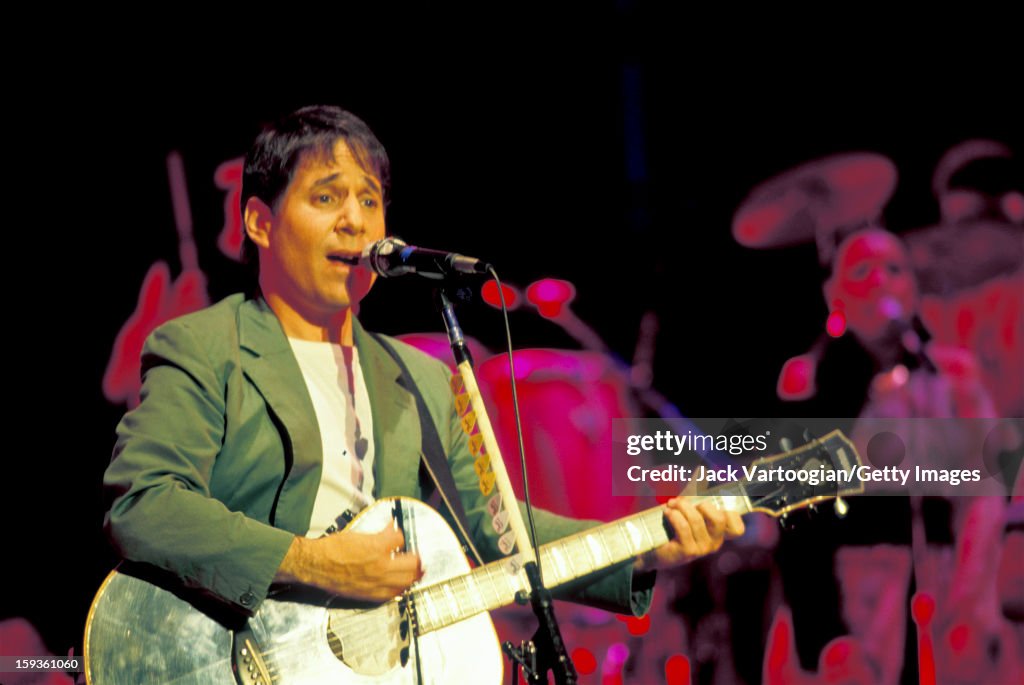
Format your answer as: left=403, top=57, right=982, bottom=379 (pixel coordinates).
left=288, top=338, right=374, bottom=538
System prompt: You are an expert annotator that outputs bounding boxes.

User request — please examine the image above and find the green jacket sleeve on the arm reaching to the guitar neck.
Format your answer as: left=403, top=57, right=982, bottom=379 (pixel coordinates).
left=440, top=358, right=655, bottom=616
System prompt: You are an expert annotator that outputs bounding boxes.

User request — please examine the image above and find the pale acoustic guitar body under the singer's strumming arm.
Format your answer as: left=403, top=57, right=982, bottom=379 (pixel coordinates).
left=85, top=499, right=502, bottom=685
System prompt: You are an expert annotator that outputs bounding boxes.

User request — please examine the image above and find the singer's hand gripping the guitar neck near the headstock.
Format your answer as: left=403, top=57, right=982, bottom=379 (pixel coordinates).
left=635, top=497, right=743, bottom=571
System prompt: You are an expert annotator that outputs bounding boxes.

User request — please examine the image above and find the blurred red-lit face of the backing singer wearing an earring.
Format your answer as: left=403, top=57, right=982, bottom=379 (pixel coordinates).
left=828, top=229, right=918, bottom=340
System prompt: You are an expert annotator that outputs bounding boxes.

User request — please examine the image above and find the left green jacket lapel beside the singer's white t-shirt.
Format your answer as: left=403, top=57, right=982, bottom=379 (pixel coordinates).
left=239, top=298, right=324, bottom=531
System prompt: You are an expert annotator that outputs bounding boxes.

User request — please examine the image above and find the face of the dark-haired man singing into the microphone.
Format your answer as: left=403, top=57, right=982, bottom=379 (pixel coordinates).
left=260, top=140, right=385, bottom=319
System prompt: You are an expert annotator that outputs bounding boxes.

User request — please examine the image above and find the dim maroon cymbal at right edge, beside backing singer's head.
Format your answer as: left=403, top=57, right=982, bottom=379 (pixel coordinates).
left=903, top=220, right=1024, bottom=296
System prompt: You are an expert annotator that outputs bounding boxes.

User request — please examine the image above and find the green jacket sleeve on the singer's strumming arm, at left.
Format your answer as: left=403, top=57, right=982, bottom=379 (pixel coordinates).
left=103, top=320, right=294, bottom=611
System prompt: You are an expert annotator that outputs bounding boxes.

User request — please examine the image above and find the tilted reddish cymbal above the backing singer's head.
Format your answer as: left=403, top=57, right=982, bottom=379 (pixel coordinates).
left=732, top=153, right=897, bottom=248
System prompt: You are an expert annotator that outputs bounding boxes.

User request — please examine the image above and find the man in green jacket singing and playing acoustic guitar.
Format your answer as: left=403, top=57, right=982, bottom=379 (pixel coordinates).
left=104, top=106, right=742, bottom=671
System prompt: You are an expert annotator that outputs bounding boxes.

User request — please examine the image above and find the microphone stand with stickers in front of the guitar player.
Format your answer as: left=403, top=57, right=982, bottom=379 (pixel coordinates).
left=438, top=285, right=579, bottom=685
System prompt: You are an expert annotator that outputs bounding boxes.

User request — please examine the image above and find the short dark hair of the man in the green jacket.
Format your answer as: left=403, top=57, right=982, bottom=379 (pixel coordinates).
left=241, top=104, right=391, bottom=267
